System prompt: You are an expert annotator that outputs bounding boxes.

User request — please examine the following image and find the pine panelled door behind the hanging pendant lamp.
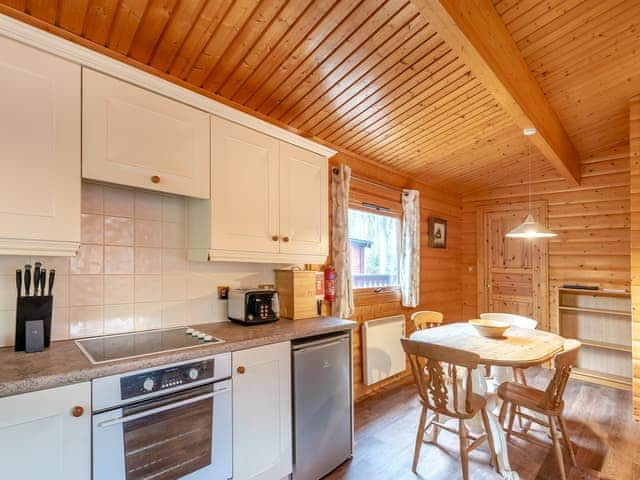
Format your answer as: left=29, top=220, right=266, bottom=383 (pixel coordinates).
left=478, top=203, right=549, bottom=329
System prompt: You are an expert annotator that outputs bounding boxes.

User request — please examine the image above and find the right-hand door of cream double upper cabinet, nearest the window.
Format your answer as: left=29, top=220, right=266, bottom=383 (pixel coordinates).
left=280, top=142, right=329, bottom=255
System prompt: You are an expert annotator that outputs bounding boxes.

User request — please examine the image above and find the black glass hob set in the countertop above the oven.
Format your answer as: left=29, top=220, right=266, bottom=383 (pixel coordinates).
left=76, top=327, right=224, bottom=364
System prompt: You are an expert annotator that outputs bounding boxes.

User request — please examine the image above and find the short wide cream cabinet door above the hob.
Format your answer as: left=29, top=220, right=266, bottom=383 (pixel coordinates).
left=82, top=68, right=209, bottom=198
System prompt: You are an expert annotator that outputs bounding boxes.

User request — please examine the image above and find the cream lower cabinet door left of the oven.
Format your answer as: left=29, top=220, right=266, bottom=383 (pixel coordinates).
left=0, top=382, right=91, bottom=480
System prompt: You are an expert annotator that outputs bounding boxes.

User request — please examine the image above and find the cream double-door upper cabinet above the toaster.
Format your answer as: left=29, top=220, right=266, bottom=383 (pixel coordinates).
left=189, top=116, right=328, bottom=263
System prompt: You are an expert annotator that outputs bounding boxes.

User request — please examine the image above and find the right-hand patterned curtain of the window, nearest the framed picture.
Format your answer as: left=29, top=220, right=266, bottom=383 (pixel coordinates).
left=400, top=190, right=420, bottom=307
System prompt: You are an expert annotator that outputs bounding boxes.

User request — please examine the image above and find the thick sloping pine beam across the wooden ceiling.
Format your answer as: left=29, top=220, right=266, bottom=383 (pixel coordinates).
left=411, top=0, right=580, bottom=185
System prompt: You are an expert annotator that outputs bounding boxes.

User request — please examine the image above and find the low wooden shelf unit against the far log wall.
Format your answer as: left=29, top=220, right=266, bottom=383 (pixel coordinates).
left=558, top=288, right=632, bottom=390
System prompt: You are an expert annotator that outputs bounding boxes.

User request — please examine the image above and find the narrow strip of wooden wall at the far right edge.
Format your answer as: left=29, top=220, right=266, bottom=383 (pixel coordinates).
left=629, top=96, right=640, bottom=420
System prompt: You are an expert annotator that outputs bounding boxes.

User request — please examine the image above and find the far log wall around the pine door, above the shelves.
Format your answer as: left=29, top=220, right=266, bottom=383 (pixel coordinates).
left=461, top=145, right=630, bottom=338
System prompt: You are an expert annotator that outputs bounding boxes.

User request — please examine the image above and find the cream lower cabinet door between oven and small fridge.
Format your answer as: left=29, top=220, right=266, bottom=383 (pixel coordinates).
left=233, top=342, right=292, bottom=480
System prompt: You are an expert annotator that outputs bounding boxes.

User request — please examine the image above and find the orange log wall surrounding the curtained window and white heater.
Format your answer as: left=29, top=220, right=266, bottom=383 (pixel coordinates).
left=331, top=154, right=463, bottom=400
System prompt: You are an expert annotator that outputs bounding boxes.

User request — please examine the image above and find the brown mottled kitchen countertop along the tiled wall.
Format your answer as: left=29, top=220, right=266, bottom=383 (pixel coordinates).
left=0, top=317, right=357, bottom=397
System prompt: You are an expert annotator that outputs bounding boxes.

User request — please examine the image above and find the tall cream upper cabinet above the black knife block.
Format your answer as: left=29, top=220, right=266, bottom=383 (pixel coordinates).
left=0, top=37, right=81, bottom=255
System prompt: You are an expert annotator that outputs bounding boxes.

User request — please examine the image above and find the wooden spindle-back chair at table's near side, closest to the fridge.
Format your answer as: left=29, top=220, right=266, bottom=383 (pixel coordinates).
left=402, top=338, right=497, bottom=480
